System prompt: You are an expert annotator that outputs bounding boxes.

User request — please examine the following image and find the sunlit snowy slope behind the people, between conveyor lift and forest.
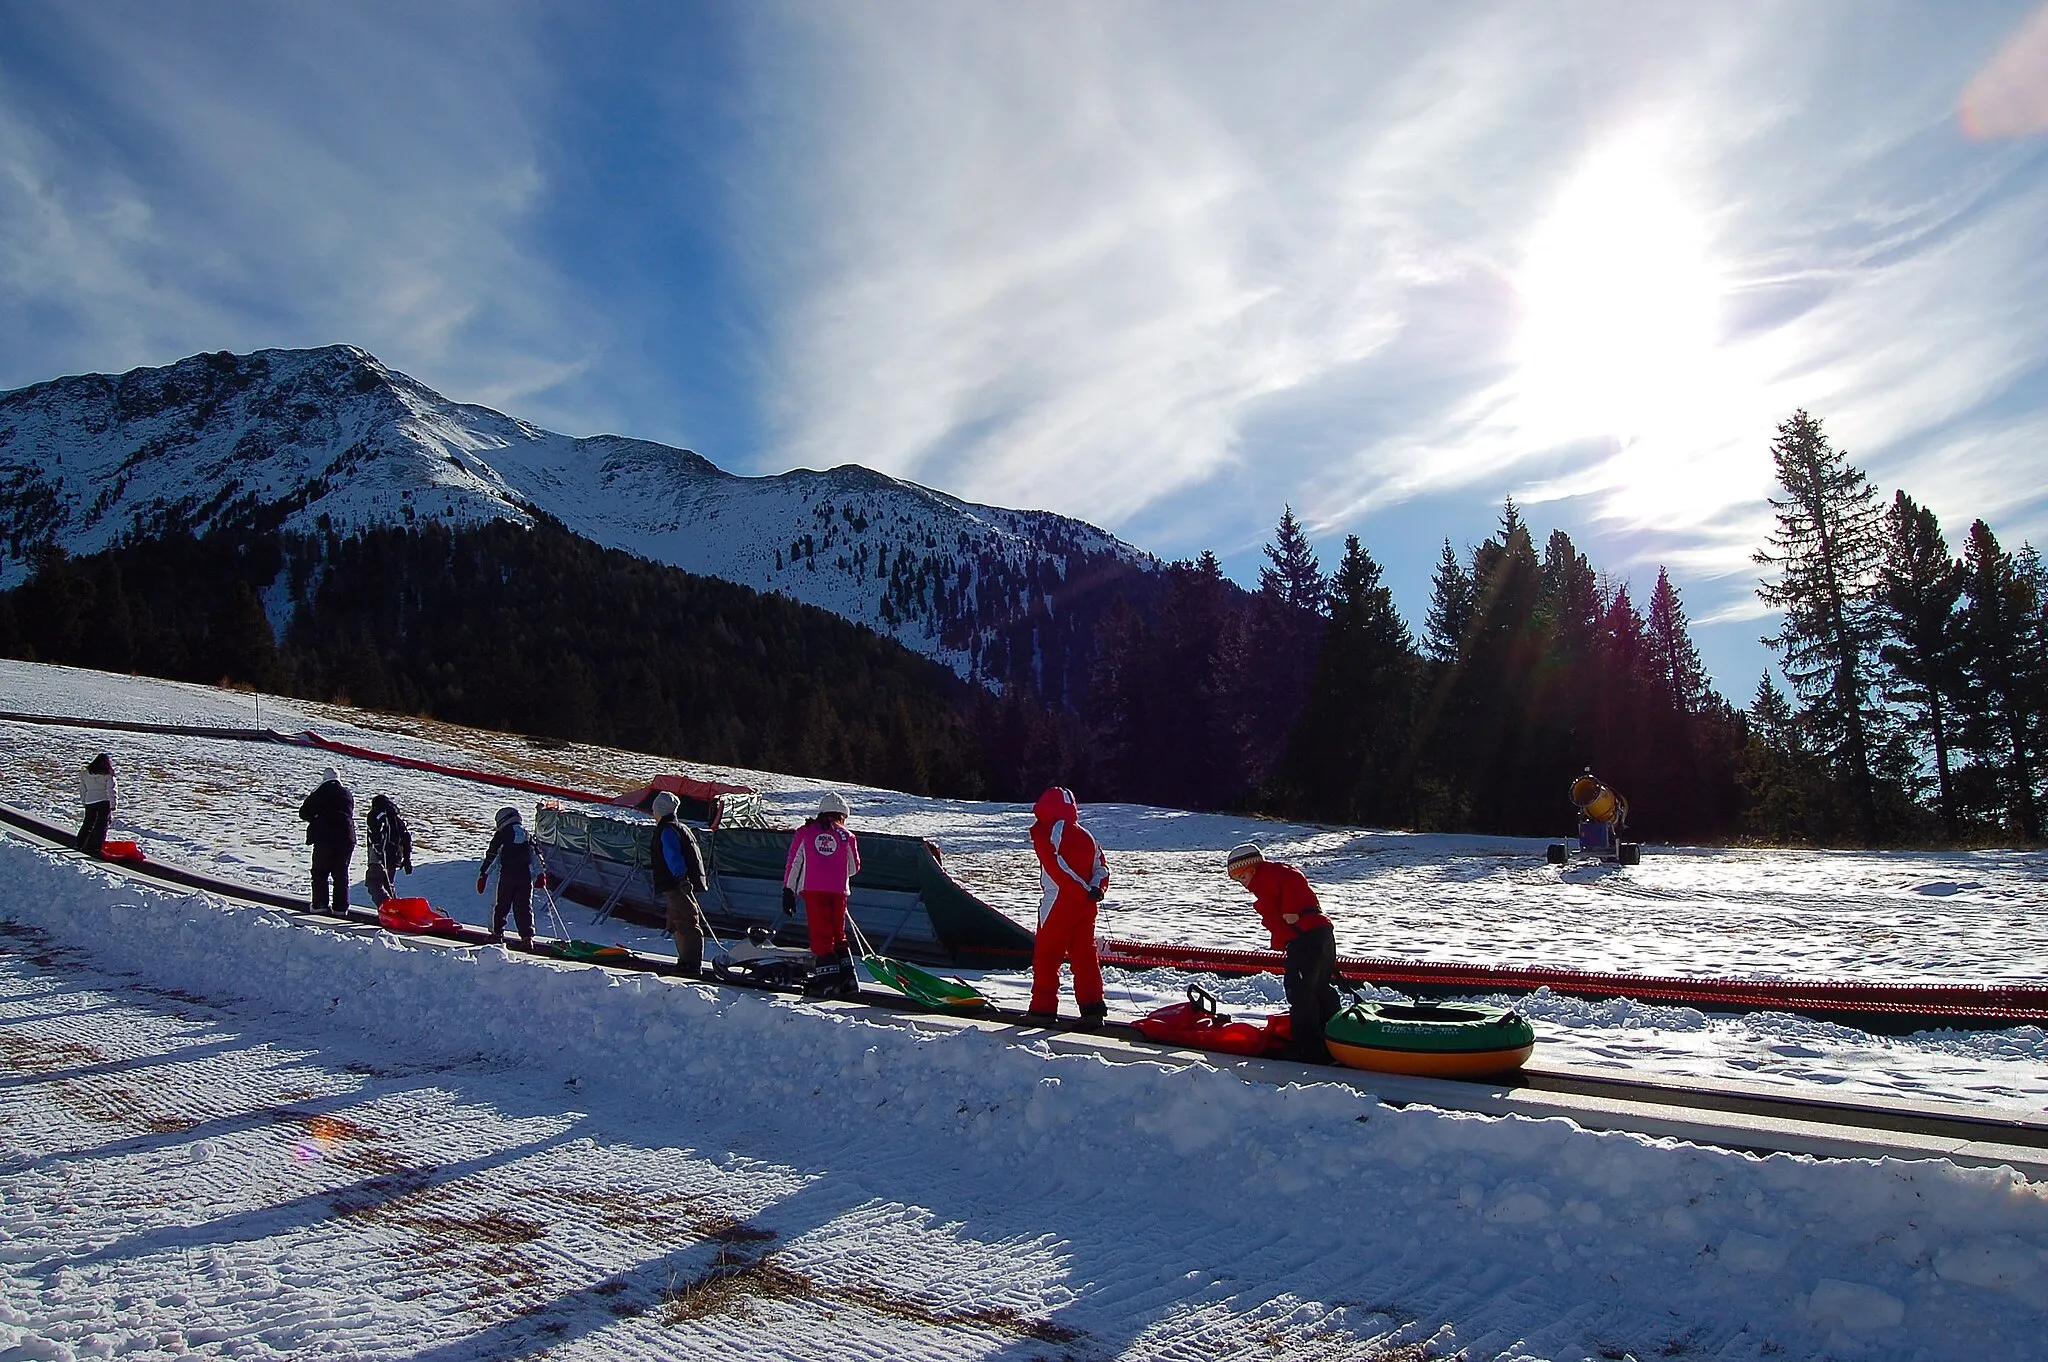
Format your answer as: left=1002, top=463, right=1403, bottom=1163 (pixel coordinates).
left=0, top=662, right=2048, bottom=1110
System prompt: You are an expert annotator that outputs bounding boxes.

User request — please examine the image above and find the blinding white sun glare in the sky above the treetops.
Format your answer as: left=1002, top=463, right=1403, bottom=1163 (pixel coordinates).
left=1516, top=133, right=1720, bottom=444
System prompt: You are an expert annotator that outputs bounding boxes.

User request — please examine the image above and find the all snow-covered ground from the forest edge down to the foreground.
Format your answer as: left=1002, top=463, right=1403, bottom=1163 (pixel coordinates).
left=12, top=664, right=2048, bottom=1362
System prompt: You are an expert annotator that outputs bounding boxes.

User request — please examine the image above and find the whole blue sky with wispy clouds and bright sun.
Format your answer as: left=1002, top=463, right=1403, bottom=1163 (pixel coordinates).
left=0, top=0, right=2048, bottom=703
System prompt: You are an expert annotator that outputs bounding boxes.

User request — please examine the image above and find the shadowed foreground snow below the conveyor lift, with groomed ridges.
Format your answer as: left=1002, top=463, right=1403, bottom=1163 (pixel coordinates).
left=0, top=842, right=2048, bottom=1358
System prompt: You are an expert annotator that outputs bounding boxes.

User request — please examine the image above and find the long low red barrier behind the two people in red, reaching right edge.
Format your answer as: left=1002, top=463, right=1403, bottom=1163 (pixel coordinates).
left=1098, top=940, right=2048, bottom=1026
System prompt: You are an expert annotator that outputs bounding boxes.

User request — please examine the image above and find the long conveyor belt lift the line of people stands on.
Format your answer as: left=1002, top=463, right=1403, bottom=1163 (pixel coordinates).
left=0, top=805, right=2048, bottom=1182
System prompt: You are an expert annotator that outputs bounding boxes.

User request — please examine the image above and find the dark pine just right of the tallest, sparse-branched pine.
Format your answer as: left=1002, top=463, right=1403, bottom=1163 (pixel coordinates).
left=1878, top=492, right=1962, bottom=842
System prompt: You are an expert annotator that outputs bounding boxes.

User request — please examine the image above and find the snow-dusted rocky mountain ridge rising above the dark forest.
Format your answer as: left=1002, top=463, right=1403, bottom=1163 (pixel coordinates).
left=0, top=346, right=1159, bottom=678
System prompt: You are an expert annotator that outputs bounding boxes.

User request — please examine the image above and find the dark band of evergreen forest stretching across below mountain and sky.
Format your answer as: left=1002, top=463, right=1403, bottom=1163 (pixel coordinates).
left=0, top=412, right=2048, bottom=846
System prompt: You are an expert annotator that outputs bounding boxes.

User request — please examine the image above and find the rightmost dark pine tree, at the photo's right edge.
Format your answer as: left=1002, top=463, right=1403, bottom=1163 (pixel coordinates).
left=1958, top=520, right=2048, bottom=842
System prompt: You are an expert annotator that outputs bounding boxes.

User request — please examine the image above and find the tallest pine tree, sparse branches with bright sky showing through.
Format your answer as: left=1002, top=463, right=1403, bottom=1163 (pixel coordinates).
left=1755, top=412, right=1884, bottom=842
